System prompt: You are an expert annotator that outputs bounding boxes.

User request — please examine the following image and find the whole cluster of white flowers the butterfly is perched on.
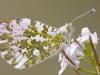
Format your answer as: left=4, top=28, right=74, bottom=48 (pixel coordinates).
left=58, top=27, right=98, bottom=75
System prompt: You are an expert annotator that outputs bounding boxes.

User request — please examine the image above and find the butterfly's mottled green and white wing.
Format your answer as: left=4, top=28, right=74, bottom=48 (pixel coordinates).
left=0, top=18, right=63, bottom=69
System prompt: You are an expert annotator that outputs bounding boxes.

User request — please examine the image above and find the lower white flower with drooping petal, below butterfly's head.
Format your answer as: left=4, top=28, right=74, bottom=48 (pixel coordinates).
left=58, top=43, right=84, bottom=75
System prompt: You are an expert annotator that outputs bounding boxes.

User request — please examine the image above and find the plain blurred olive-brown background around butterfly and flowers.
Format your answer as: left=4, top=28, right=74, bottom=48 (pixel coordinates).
left=0, top=0, right=100, bottom=75
